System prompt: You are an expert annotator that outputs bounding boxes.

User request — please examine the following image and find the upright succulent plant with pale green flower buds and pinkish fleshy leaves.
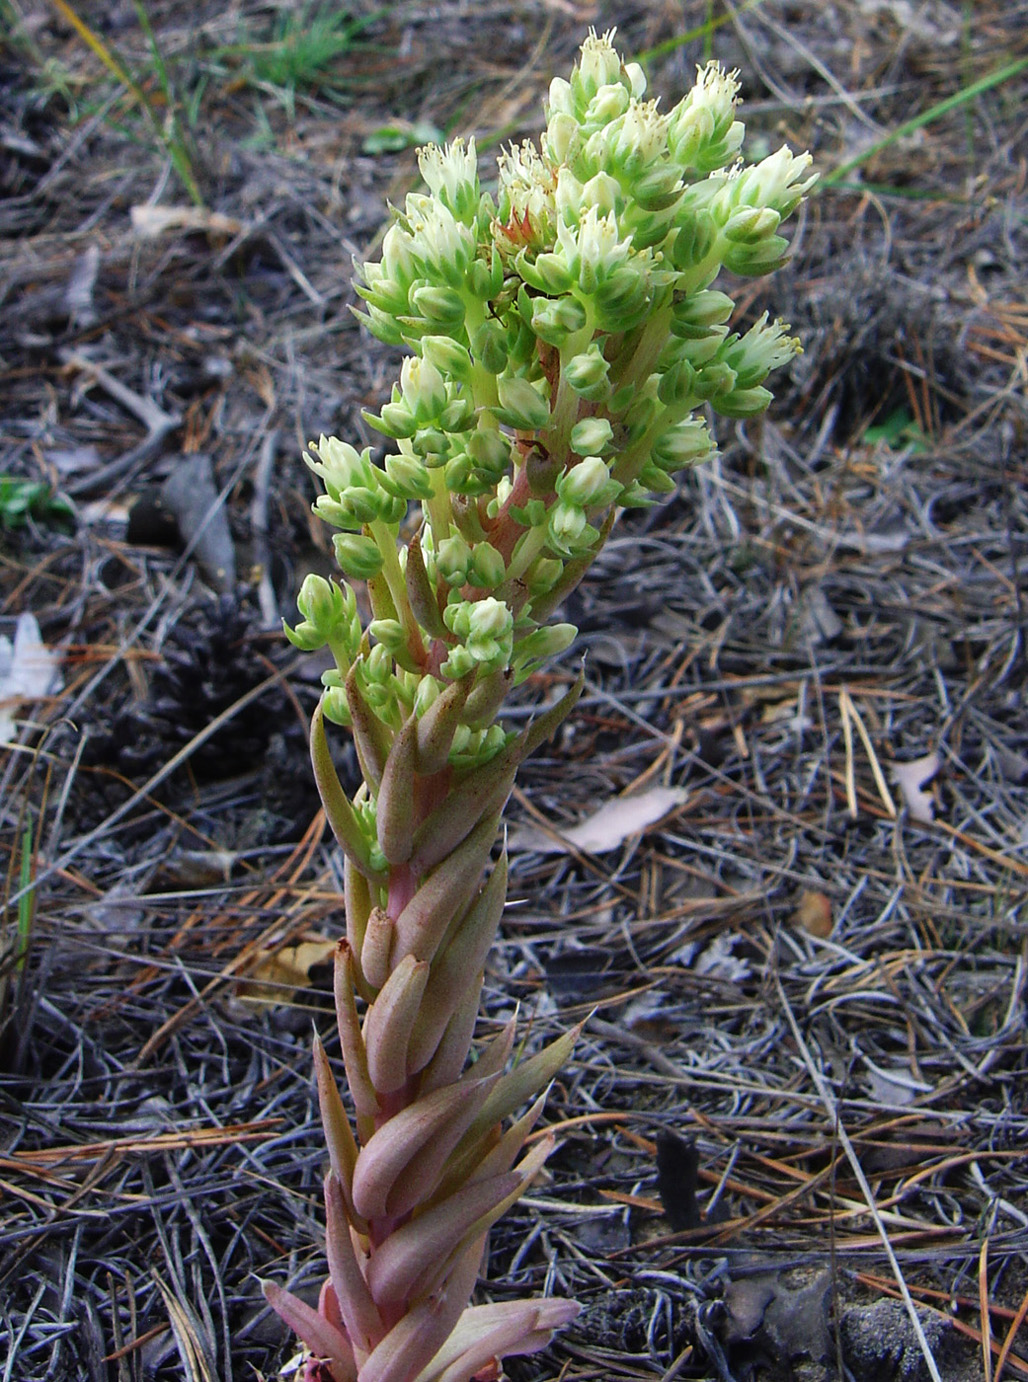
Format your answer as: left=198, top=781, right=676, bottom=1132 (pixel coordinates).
left=279, top=29, right=812, bottom=1382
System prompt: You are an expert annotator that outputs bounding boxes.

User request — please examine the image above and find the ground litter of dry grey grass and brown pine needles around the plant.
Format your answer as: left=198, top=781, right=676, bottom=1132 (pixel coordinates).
left=0, top=0, right=1028, bottom=1382
